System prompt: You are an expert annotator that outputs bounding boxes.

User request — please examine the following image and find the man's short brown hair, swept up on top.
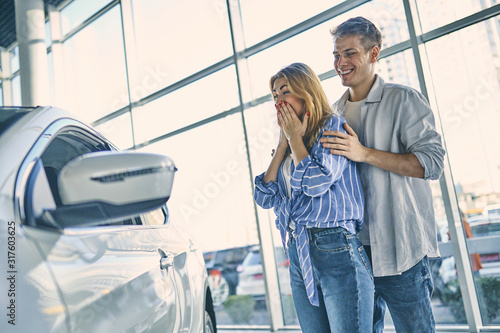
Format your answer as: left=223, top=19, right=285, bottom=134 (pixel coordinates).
left=330, top=16, right=382, bottom=51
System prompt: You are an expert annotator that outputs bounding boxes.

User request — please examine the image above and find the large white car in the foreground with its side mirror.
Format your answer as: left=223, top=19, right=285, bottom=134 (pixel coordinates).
left=0, top=107, right=216, bottom=333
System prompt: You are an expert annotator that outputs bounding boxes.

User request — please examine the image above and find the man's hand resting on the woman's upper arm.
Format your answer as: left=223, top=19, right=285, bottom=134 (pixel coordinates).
left=320, top=123, right=368, bottom=162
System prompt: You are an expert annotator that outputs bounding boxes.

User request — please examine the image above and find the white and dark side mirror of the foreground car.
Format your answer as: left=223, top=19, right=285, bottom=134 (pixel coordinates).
left=42, top=151, right=177, bottom=228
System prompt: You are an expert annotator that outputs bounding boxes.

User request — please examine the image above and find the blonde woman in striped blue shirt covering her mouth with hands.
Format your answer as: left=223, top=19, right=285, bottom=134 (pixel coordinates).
left=255, top=63, right=374, bottom=333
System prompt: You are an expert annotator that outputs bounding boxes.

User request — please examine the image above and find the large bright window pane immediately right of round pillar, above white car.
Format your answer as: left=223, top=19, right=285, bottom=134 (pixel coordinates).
left=63, top=5, right=129, bottom=122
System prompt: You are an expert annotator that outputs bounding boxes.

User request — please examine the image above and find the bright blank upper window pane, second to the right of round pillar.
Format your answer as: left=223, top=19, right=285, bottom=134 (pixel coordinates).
left=131, top=0, right=232, bottom=90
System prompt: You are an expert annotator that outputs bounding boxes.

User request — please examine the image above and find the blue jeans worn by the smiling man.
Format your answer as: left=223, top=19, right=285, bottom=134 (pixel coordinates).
left=366, top=246, right=436, bottom=333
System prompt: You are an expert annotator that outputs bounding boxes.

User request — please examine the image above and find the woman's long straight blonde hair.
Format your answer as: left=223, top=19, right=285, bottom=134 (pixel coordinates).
left=269, top=62, right=333, bottom=151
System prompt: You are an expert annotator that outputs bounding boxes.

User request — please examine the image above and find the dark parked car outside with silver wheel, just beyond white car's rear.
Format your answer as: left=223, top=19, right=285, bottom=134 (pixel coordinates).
left=203, top=245, right=251, bottom=306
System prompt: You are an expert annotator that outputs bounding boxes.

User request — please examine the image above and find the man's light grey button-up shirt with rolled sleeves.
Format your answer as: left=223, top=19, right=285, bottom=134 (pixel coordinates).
left=334, top=75, right=445, bottom=276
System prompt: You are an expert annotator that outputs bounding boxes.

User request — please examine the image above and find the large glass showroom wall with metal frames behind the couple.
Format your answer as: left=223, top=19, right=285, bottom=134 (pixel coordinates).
left=1, top=0, right=500, bottom=331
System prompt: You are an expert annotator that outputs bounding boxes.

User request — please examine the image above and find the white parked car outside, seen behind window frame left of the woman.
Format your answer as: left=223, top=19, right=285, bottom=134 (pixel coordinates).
left=236, top=246, right=292, bottom=301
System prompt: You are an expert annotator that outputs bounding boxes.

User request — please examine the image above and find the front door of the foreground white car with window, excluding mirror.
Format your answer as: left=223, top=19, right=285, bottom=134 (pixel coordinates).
left=21, top=122, right=189, bottom=332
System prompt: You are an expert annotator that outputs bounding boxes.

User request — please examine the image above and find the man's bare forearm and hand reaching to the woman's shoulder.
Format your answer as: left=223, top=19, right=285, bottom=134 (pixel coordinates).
left=320, top=123, right=425, bottom=178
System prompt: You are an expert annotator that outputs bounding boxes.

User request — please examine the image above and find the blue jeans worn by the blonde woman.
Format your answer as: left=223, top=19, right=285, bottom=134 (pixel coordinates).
left=288, top=227, right=374, bottom=333
